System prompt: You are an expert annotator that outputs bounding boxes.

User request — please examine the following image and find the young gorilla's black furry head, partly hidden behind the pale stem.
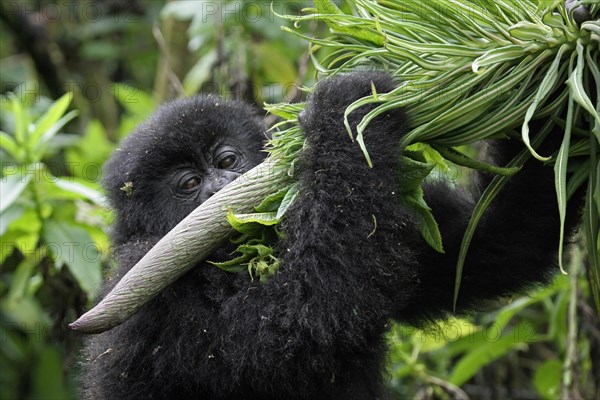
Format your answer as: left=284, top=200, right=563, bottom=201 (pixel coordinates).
left=104, top=96, right=266, bottom=245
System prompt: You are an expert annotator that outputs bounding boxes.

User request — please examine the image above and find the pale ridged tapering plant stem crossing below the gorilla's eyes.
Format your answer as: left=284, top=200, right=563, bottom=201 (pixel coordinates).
left=69, top=158, right=289, bottom=333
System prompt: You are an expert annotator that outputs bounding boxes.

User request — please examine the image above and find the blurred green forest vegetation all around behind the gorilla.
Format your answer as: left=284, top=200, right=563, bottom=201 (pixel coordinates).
left=0, top=0, right=600, bottom=400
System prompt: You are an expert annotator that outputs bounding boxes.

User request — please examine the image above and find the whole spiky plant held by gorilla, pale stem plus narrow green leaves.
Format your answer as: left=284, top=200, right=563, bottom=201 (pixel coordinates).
left=73, top=0, right=600, bottom=332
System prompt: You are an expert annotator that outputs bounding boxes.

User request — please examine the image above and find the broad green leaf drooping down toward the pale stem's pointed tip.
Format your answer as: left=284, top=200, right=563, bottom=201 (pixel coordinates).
left=43, top=220, right=102, bottom=299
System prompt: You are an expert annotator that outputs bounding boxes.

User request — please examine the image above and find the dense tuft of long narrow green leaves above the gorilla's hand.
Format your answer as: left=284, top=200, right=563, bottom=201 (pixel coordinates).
left=276, top=0, right=600, bottom=309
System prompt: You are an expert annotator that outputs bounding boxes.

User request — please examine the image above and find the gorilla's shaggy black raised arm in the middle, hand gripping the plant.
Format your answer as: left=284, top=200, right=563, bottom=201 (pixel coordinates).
left=196, top=74, right=416, bottom=399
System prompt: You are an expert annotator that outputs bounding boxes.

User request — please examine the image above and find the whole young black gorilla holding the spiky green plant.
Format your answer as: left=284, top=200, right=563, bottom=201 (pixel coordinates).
left=84, top=72, right=575, bottom=400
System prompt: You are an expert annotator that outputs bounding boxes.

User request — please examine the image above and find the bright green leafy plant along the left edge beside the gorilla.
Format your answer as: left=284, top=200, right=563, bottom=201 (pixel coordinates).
left=0, top=91, right=108, bottom=398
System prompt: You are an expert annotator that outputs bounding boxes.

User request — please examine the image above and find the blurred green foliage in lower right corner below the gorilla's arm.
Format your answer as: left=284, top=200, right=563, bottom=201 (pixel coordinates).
left=387, top=248, right=597, bottom=400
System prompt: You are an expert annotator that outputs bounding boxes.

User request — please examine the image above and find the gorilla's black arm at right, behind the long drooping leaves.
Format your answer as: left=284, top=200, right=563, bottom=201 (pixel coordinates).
left=396, top=120, right=583, bottom=323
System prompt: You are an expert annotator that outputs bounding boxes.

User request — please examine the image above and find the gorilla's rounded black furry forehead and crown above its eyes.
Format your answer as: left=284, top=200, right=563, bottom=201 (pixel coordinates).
left=106, top=95, right=265, bottom=175
